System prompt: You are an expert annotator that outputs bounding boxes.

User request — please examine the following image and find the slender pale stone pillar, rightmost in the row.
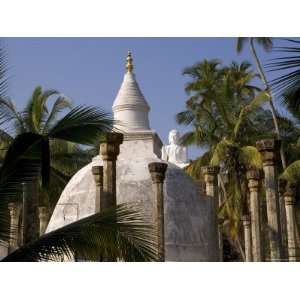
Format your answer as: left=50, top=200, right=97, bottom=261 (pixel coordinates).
left=284, top=186, right=297, bottom=261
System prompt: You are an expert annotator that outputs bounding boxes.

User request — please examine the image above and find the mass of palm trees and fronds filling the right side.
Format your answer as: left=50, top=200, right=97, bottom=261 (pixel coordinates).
left=176, top=38, right=300, bottom=259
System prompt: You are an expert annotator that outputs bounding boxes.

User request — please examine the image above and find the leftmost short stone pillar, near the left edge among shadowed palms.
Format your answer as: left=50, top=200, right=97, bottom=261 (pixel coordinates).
left=8, top=202, right=21, bottom=253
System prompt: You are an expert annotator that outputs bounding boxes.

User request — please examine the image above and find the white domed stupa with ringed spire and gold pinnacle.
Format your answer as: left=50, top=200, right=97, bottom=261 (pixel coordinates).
left=47, top=53, right=219, bottom=261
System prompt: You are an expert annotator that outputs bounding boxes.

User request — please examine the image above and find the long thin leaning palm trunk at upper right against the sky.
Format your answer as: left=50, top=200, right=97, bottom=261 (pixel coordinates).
left=250, top=38, right=286, bottom=169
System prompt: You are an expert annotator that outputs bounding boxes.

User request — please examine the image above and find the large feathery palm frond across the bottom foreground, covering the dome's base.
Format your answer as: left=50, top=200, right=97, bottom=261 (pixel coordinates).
left=3, top=205, right=156, bottom=261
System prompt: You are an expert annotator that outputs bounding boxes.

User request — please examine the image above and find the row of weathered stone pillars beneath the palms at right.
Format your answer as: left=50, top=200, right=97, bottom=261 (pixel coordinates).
left=202, top=139, right=297, bottom=261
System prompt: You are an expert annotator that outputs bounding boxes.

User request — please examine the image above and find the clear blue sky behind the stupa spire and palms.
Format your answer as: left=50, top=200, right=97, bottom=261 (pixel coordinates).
left=2, top=38, right=288, bottom=158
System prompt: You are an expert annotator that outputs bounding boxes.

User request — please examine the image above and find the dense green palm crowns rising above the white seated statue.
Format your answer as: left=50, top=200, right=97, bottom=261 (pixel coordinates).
left=176, top=60, right=265, bottom=159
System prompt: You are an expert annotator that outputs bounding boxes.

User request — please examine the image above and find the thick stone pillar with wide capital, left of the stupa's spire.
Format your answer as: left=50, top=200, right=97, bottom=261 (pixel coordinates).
left=100, top=132, right=123, bottom=209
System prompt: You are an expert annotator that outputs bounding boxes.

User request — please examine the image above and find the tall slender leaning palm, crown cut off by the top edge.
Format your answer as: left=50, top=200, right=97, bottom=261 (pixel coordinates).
left=237, top=37, right=286, bottom=169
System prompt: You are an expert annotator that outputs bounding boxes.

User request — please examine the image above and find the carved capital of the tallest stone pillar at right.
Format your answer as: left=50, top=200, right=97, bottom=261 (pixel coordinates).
left=256, top=139, right=281, bottom=166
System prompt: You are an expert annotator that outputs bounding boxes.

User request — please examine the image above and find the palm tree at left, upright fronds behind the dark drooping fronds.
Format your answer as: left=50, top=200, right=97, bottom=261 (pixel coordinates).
left=0, top=86, right=91, bottom=214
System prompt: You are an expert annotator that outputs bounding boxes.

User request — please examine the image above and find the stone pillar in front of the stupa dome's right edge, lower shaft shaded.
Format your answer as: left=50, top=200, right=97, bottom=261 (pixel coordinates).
left=201, top=166, right=223, bottom=261
